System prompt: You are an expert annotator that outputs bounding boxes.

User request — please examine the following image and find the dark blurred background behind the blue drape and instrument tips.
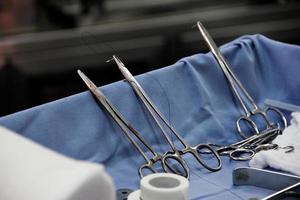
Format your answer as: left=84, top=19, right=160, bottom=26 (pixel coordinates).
left=0, top=0, right=300, bottom=116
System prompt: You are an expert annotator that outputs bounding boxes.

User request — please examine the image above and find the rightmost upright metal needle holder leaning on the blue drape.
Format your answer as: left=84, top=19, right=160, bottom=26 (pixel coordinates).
left=197, top=21, right=287, bottom=138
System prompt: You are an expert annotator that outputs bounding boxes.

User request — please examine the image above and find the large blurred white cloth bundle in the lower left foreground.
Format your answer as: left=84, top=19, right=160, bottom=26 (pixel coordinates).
left=0, top=127, right=116, bottom=200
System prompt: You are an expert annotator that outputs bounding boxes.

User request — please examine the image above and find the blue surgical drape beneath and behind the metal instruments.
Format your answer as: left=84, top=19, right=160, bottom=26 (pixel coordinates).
left=0, top=35, right=300, bottom=199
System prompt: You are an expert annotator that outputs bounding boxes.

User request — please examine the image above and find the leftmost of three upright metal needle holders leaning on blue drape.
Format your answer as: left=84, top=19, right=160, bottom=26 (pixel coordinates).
left=77, top=70, right=188, bottom=178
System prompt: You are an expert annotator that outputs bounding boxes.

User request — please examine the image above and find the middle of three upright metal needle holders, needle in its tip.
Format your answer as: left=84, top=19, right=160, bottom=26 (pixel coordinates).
left=113, top=55, right=222, bottom=177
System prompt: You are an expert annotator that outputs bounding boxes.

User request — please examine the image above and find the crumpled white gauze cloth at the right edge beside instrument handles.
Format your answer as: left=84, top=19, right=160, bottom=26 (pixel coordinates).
left=249, top=112, right=300, bottom=176
